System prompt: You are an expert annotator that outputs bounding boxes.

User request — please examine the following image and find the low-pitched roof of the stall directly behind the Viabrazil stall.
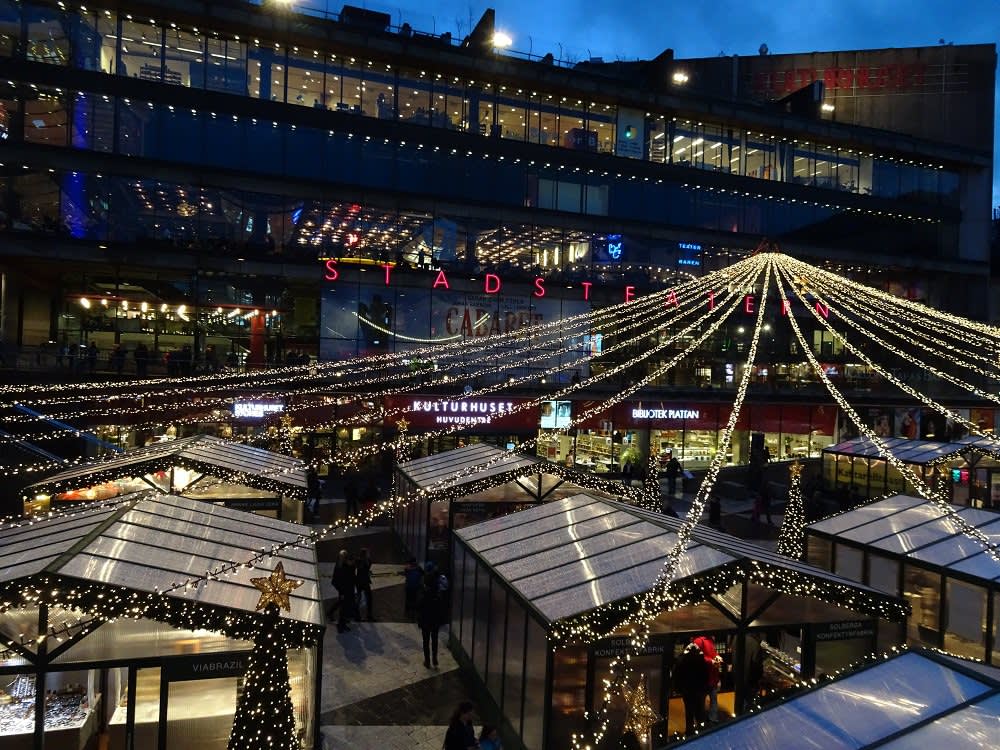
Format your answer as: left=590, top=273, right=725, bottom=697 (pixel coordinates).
left=25, top=435, right=306, bottom=496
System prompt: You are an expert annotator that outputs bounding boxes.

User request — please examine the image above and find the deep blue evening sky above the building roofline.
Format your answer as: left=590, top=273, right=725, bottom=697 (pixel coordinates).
left=322, top=0, right=1000, bottom=206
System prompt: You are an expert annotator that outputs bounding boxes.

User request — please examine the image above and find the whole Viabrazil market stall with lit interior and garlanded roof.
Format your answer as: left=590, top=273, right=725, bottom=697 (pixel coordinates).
left=0, top=494, right=325, bottom=750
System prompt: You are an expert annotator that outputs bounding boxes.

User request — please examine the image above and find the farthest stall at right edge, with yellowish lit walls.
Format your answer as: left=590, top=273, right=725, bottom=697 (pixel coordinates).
left=822, top=435, right=1000, bottom=508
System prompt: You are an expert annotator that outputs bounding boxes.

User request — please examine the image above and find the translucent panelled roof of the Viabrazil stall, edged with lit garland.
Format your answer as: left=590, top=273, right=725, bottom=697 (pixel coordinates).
left=0, top=492, right=325, bottom=640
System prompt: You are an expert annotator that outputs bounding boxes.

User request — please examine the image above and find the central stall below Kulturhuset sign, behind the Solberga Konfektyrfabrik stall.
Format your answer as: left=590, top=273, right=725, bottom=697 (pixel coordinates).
left=393, top=443, right=620, bottom=566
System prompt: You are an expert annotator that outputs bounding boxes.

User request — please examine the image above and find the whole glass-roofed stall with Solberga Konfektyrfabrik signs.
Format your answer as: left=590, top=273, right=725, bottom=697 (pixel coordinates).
left=451, top=494, right=907, bottom=750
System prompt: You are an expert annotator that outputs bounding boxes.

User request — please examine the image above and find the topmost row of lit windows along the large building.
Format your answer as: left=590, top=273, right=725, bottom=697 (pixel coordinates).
left=0, top=2, right=958, bottom=205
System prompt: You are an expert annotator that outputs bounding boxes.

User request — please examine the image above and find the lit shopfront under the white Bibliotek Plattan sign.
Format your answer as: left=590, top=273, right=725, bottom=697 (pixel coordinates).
left=538, top=400, right=837, bottom=474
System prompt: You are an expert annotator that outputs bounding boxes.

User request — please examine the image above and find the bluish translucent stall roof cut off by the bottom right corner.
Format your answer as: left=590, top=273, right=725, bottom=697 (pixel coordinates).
left=684, top=649, right=1000, bottom=750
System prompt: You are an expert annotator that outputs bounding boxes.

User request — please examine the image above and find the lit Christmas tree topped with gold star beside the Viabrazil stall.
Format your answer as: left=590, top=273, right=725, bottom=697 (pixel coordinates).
left=229, top=562, right=302, bottom=750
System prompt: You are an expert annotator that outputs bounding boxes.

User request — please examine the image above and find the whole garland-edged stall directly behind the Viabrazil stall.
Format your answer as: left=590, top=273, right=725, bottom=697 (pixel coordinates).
left=24, top=435, right=306, bottom=521
